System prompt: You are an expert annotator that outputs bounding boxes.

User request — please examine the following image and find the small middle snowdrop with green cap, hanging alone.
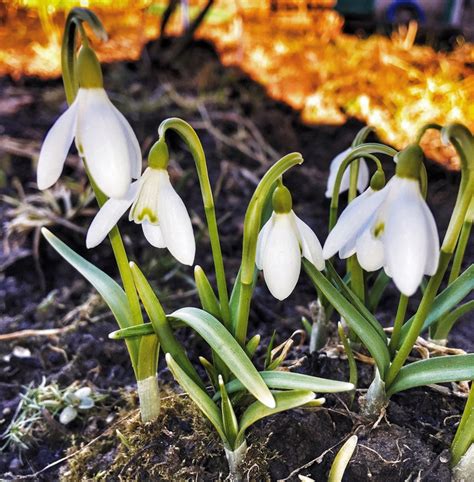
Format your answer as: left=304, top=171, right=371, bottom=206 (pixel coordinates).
left=256, top=184, right=324, bottom=300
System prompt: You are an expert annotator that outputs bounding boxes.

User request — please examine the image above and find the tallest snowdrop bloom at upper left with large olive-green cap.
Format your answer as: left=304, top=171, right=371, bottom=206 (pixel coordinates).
left=37, top=46, right=142, bottom=198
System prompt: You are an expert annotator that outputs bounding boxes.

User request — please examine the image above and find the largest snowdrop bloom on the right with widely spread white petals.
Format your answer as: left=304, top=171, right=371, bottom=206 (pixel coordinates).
left=323, top=145, right=439, bottom=296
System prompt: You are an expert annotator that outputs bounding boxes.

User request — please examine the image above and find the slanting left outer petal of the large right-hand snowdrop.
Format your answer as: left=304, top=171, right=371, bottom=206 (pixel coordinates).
left=323, top=185, right=388, bottom=259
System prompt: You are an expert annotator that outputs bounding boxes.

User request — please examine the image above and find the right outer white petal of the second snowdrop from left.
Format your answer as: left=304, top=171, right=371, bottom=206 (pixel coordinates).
left=158, top=169, right=196, bottom=265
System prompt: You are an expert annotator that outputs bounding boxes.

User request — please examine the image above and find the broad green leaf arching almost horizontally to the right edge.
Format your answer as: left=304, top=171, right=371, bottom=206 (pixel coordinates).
left=387, top=353, right=474, bottom=397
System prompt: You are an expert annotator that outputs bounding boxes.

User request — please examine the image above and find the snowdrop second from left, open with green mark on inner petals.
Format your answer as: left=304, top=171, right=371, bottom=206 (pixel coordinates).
left=86, top=141, right=196, bottom=265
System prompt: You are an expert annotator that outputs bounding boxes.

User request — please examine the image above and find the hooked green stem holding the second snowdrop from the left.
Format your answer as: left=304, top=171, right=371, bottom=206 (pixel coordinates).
left=158, top=117, right=231, bottom=329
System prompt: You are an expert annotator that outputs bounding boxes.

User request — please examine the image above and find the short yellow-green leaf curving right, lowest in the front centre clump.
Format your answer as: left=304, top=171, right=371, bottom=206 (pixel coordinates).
left=235, top=390, right=316, bottom=446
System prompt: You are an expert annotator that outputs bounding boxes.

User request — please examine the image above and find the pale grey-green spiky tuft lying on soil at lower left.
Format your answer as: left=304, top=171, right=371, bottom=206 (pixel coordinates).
left=2, top=378, right=107, bottom=449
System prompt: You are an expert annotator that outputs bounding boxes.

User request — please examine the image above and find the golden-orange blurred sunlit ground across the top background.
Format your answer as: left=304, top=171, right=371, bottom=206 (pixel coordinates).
left=0, top=0, right=474, bottom=169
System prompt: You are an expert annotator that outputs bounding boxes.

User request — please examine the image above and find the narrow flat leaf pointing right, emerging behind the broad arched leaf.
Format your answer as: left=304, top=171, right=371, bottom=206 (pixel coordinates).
left=214, top=371, right=355, bottom=399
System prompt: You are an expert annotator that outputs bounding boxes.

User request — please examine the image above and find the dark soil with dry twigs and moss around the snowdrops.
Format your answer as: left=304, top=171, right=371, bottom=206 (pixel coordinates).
left=0, top=36, right=474, bottom=481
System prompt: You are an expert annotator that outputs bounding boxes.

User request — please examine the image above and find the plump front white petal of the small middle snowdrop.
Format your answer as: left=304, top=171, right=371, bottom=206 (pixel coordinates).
left=263, top=214, right=301, bottom=300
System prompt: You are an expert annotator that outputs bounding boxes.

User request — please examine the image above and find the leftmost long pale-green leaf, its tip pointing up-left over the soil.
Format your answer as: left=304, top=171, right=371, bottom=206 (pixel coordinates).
left=41, top=228, right=139, bottom=362
